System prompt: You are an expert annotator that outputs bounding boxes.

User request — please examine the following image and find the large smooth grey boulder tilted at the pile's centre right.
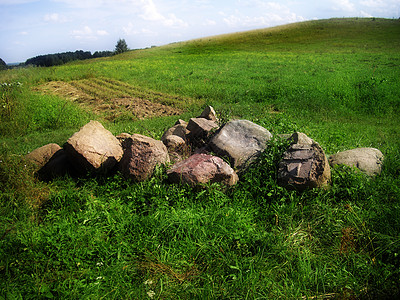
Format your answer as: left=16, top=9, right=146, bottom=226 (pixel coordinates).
left=210, top=120, right=272, bottom=170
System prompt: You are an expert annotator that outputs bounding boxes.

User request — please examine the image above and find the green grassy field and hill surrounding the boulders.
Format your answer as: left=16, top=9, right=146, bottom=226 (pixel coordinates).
left=0, top=18, right=400, bottom=299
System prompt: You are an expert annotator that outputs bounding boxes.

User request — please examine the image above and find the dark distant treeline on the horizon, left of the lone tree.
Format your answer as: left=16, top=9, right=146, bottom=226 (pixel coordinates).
left=25, top=50, right=114, bottom=67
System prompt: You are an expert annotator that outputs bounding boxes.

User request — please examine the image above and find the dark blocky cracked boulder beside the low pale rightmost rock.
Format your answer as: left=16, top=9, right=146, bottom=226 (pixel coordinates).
left=278, top=143, right=331, bottom=191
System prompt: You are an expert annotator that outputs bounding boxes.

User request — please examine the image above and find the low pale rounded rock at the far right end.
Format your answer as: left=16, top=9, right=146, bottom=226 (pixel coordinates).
left=329, top=148, right=383, bottom=176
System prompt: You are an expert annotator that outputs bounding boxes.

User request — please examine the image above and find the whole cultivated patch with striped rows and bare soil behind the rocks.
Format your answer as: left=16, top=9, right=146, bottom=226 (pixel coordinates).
left=34, top=79, right=187, bottom=121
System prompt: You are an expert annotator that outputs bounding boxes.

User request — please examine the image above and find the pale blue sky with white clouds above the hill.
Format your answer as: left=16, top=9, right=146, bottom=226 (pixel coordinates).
left=0, top=0, right=400, bottom=63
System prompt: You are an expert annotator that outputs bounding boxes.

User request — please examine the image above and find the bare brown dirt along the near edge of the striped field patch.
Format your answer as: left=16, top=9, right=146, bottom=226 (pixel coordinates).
left=34, top=81, right=182, bottom=121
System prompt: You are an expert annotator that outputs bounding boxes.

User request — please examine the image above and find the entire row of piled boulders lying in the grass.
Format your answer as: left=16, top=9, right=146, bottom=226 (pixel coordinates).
left=26, top=107, right=383, bottom=190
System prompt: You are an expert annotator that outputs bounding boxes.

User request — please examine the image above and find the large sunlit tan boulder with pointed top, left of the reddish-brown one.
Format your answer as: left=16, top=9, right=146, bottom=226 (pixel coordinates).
left=64, top=121, right=123, bottom=173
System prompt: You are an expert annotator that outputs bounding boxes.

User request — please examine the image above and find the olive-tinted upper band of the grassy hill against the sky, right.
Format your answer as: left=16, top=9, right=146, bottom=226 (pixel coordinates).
left=125, top=18, right=400, bottom=55
